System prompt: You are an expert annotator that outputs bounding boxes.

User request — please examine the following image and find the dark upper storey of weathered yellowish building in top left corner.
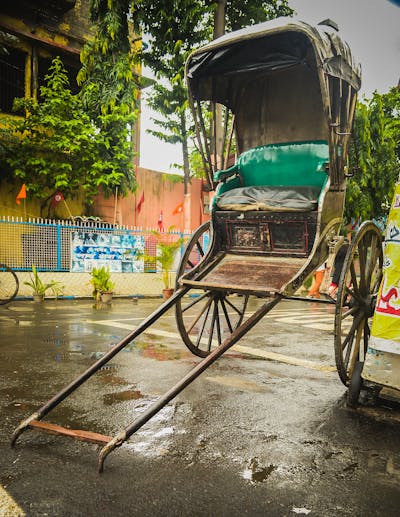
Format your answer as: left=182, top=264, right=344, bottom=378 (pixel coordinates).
left=0, top=0, right=90, bottom=114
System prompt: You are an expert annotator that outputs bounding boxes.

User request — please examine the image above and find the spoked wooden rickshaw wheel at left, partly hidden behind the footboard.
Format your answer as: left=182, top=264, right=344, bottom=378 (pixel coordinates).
left=175, top=222, right=249, bottom=357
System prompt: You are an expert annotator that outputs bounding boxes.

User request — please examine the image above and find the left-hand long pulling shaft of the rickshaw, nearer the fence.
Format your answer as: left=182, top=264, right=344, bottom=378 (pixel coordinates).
left=11, top=287, right=190, bottom=447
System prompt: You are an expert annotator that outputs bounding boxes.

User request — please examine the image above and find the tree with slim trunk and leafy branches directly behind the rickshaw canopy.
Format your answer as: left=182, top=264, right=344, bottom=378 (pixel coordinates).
left=133, top=0, right=293, bottom=193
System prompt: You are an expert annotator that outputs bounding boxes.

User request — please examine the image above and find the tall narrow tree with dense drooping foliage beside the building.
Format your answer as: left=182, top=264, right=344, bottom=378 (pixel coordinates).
left=77, top=0, right=139, bottom=194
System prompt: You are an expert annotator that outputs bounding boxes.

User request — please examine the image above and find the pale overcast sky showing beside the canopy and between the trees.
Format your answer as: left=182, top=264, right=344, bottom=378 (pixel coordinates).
left=140, top=0, right=400, bottom=172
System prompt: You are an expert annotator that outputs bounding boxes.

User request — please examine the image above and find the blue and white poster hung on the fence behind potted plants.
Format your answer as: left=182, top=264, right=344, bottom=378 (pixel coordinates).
left=71, top=231, right=145, bottom=273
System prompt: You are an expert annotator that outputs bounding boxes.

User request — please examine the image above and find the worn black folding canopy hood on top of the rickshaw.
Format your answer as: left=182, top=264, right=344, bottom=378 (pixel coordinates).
left=186, top=18, right=361, bottom=106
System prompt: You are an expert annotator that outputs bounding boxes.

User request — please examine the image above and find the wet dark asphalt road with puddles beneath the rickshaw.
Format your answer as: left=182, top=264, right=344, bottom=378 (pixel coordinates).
left=0, top=300, right=400, bottom=517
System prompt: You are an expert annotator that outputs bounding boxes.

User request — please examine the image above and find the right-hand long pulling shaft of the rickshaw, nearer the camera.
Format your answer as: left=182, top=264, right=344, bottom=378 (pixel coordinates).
left=98, top=294, right=282, bottom=473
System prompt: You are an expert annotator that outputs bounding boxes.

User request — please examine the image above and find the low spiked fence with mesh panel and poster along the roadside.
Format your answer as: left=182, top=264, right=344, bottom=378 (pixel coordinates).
left=0, top=216, right=190, bottom=273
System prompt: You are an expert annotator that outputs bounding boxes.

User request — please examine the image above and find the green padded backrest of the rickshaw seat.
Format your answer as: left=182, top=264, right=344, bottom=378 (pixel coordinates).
left=238, top=140, right=329, bottom=189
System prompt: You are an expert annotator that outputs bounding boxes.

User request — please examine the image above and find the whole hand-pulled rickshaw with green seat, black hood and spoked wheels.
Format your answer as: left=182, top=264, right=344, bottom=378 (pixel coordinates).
left=12, top=18, right=382, bottom=471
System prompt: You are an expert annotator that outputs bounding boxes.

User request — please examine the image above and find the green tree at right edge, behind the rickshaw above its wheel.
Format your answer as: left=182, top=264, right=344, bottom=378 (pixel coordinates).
left=345, top=88, right=400, bottom=221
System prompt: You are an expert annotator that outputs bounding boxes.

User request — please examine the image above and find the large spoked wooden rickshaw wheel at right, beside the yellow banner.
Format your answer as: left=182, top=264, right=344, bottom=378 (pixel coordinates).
left=335, top=221, right=383, bottom=388
